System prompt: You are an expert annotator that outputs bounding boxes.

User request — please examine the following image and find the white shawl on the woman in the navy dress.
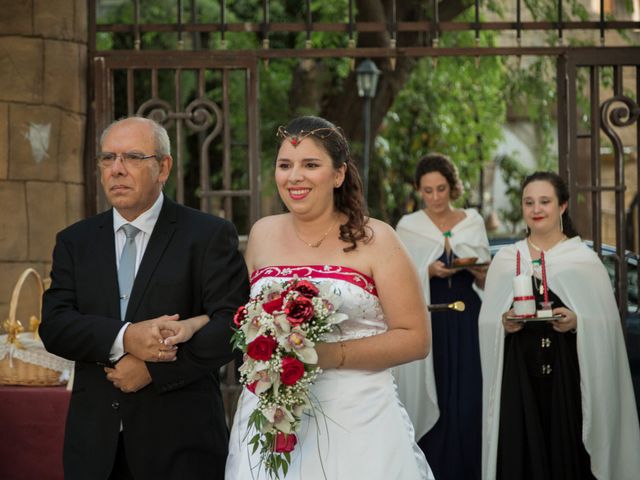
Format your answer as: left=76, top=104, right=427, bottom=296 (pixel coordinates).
left=394, top=208, right=491, bottom=440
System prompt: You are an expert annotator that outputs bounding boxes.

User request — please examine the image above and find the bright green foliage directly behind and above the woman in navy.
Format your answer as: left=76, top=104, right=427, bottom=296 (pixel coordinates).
left=376, top=11, right=509, bottom=224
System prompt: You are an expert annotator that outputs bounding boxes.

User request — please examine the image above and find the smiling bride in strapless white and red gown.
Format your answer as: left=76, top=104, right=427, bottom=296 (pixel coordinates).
left=226, top=117, right=432, bottom=480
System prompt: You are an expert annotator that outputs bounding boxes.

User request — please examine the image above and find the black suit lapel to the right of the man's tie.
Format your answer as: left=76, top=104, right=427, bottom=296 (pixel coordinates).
left=125, top=197, right=177, bottom=322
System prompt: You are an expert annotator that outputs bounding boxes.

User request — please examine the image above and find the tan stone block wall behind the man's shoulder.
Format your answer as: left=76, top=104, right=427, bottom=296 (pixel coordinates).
left=0, top=0, right=88, bottom=322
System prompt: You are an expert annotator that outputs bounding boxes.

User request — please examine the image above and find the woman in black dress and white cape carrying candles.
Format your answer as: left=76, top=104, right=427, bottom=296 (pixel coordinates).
left=480, top=172, right=640, bottom=480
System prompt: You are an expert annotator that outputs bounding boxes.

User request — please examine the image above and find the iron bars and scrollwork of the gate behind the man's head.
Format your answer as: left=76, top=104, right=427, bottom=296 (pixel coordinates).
left=90, top=52, right=260, bottom=233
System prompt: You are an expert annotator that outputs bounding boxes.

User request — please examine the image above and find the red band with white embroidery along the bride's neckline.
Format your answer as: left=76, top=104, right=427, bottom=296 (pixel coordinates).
left=251, top=265, right=378, bottom=296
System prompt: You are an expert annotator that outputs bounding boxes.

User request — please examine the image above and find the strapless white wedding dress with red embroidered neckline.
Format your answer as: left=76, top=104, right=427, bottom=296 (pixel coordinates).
left=225, top=266, right=433, bottom=480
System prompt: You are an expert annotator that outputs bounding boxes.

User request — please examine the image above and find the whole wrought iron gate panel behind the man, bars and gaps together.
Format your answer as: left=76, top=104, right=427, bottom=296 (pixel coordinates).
left=92, top=51, right=260, bottom=234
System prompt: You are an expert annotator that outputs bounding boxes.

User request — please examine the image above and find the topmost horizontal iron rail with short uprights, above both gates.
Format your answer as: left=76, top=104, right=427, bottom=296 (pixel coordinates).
left=89, top=0, right=640, bottom=58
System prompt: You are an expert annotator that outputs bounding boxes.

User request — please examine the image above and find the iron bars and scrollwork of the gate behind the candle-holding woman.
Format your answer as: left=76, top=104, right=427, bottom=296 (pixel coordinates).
left=557, top=49, right=640, bottom=326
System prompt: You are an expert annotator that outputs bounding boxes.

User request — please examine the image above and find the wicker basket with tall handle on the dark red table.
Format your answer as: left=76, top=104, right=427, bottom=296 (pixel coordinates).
left=0, top=268, right=73, bottom=387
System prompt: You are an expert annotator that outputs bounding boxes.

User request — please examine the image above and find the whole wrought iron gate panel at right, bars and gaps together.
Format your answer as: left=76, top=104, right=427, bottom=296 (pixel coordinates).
left=557, top=48, right=640, bottom=322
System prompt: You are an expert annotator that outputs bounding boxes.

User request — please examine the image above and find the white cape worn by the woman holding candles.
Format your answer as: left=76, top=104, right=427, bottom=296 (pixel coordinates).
left=479, top=237, right=640, bottom=480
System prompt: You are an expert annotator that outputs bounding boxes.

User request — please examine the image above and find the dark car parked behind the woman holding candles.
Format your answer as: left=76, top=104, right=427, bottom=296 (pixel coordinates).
left=489, top=238, right=640, bottom=415
